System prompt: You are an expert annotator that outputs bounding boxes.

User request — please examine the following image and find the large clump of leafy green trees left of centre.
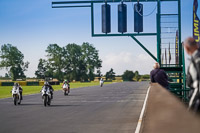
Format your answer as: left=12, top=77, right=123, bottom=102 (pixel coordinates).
left=35, top=43, right=102, bottom=81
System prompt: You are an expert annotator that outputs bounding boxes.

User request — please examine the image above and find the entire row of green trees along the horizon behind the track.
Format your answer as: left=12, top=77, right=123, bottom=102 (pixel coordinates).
left=0, top=42, right=150, bottom=81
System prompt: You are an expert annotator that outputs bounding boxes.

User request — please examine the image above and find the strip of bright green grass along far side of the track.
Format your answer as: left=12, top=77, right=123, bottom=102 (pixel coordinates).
left=0, top=82, right=112, bottom=98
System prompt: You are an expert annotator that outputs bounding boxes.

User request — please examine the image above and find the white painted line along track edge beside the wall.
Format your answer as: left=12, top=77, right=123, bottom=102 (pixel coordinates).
left=135, top=87, right=150, bottom=133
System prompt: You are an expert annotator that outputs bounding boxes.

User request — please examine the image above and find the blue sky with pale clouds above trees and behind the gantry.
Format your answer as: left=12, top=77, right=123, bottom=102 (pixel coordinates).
left=0, top=0, right=199, bottom=77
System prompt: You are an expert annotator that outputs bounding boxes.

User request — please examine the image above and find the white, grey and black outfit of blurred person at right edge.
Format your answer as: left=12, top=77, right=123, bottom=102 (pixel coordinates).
left=187, top=51, right=200, bottom=112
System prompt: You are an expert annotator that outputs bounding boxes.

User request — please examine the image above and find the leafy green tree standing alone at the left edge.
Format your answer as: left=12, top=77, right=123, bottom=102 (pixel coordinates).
left=0, top=44, right=29, bottom=81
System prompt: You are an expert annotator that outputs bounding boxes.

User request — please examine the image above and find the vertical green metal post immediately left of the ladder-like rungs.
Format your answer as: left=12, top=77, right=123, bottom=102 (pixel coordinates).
left=156, top=0, right=161, bottom=64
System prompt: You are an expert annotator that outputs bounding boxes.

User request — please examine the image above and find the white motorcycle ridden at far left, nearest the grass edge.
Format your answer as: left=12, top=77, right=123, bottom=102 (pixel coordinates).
left=11, top=86, right=21, bottom=105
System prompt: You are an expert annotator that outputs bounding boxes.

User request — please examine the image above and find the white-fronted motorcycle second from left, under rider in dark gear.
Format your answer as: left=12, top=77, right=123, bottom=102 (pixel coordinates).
left=41, top=86, right=51, bottom=106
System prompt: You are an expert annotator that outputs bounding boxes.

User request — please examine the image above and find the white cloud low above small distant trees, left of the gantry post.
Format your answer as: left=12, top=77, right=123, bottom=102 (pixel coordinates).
left=102, top=52, right=155, bottom=75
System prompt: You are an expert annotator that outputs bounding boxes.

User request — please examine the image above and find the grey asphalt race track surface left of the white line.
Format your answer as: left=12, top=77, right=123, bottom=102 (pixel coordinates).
left=0, top=82, right=148, bottom=133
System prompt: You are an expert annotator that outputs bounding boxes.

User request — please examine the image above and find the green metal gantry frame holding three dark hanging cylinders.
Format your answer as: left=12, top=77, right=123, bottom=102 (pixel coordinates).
left=52, top=0, right=189, bottom=101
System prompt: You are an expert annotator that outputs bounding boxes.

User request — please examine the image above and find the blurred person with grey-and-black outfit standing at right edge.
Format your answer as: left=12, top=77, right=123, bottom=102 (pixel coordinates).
left=183, top=37, right=200, bottom=112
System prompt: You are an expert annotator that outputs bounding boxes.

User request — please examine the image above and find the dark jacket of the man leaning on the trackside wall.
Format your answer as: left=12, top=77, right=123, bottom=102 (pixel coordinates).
left=150, top=69, right=169, bottom=89
